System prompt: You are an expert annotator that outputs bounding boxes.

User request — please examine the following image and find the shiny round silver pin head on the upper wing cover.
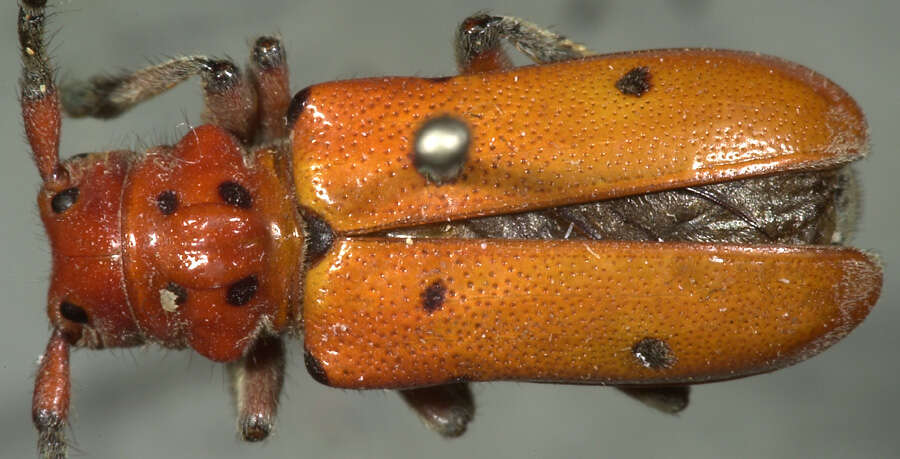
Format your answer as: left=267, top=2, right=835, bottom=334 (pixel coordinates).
left=412, top=115, right=472, bottom=185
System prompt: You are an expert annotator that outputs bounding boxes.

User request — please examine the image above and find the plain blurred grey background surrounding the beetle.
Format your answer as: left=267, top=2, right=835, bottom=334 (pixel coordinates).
left=0, top=0, right=900, bottom=459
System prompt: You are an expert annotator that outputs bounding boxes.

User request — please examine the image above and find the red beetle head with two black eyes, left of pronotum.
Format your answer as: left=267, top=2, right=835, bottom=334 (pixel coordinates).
left=38, top=151, right=141, bottom=348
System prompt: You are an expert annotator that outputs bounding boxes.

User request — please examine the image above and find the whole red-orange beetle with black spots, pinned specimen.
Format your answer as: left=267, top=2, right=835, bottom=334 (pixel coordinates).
left=19, top=1, right=881, bottom=456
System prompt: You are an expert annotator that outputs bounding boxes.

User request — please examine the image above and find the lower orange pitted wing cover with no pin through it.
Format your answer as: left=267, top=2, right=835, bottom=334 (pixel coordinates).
left=303, top=239, right=881, bottom=389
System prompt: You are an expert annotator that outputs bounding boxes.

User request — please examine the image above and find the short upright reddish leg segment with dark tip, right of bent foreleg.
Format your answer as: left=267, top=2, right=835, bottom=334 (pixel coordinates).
left=250, top=37, right=291, bottom=141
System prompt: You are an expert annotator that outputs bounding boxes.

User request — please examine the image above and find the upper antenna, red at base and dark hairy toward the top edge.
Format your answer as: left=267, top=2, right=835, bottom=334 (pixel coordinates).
left=18, top=0, right=67, bottom=184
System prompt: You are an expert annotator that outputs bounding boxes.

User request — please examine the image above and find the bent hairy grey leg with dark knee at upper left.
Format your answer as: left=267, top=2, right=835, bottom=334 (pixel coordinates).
left=61, top=56, right=256, bottom=141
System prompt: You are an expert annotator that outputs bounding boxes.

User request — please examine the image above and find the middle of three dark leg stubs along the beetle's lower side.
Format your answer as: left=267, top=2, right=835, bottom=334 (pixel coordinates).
left=399, top=383, right=475, bottom=438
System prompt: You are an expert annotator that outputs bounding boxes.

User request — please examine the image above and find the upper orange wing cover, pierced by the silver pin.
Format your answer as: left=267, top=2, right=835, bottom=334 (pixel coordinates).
left=291, top=50, right=867, bottom=234
